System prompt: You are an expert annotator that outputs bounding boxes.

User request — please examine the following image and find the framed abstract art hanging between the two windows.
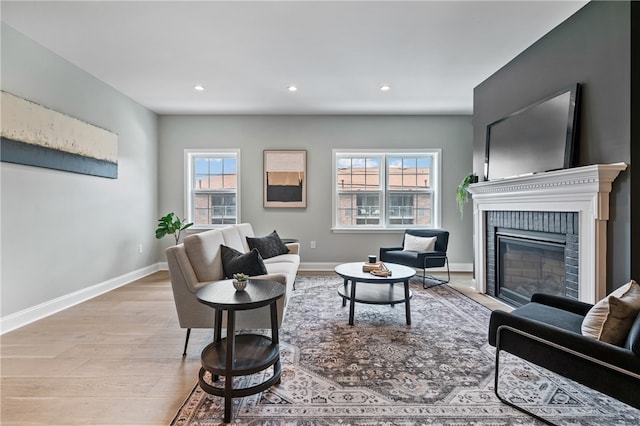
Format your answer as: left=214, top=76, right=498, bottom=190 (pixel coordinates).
left=263, top=150, right=307, bottom=208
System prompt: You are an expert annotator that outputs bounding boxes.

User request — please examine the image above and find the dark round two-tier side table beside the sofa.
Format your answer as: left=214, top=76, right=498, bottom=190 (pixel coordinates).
left=196, top=279, right=286, bottom=423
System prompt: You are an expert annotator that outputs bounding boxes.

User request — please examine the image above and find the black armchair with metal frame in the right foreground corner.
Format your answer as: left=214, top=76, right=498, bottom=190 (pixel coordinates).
left=489, top=293, right=640, bottom=424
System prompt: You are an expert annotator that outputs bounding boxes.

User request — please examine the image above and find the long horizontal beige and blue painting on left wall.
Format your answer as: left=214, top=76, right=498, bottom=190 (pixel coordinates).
left=0, top=92, right=118, bottom=179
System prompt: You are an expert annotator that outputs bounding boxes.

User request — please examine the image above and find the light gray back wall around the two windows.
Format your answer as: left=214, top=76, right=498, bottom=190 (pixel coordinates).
left=158, top=116, right=473, bottom=268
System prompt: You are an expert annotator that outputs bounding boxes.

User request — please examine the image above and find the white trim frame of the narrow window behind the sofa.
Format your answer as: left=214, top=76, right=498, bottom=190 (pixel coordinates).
left=183, top=149, right=242, bottom=230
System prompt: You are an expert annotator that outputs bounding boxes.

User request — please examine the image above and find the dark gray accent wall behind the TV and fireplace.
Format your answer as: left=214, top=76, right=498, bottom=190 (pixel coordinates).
left=473, top=1, right=640, bottom=290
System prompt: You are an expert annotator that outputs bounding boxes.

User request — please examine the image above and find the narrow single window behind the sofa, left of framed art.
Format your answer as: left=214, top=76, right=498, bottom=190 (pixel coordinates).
left=185, top=150, right=240, bottom=227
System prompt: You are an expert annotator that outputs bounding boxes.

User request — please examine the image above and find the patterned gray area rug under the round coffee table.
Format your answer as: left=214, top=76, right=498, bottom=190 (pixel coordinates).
left=172, top=276, right=640, bottom=426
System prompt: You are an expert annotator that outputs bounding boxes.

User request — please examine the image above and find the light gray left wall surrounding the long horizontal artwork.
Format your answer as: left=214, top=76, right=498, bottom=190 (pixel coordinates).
left=0, top=23, right=157, bottom=317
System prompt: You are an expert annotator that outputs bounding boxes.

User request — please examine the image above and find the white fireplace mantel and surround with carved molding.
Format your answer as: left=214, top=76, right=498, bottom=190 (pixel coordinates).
left=469, top=163, right=627, bottom=303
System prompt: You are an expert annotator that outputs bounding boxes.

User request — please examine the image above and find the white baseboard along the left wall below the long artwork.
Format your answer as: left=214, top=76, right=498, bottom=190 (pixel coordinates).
left=0, top=262, right=166, bottom=335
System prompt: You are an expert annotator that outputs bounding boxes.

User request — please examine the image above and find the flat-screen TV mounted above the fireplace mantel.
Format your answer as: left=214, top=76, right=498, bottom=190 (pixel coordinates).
left=484, top=84, right=580, bottom=180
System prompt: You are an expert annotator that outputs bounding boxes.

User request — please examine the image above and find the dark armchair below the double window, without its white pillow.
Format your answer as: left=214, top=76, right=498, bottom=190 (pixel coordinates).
left=380, top=229, right=451, bottom=288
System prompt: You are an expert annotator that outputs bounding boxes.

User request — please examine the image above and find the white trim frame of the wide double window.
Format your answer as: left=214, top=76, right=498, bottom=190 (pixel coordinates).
left=331, top=148, right=442, bottom=234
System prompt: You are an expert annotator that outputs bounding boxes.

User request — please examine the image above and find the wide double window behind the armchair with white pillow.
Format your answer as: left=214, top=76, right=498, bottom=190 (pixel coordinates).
left=333, top=150, right=440, bottom=230
